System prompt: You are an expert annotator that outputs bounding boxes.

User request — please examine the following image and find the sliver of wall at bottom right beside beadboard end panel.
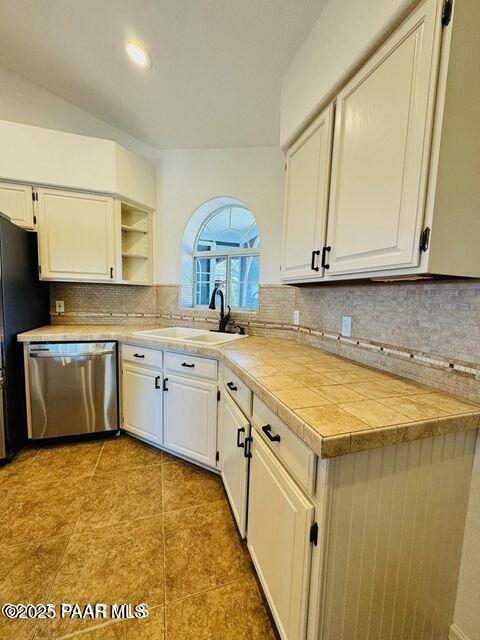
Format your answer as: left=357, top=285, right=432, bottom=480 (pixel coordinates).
left=453, top=437, right=480, bottom=640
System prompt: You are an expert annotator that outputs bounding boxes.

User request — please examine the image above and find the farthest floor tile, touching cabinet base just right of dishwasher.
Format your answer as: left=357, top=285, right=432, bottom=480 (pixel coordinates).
left=97, top=436, right=165, bottom=473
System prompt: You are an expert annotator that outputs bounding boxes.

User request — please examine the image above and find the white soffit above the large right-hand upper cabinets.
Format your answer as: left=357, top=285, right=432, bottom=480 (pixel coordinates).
left=280, top=0, right=416, bottom=147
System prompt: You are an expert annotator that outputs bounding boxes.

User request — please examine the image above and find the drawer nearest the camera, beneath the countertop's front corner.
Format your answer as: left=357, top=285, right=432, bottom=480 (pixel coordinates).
left=252, top=396, right=316, bottom=495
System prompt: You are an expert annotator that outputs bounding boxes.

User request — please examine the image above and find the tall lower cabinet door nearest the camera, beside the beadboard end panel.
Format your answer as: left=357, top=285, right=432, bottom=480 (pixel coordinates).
left=247, top=430, right=314, bottom=640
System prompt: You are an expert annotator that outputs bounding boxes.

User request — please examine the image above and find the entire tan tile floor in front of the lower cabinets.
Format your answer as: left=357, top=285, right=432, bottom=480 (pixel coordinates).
left=0, top=436, right=275, bottom=640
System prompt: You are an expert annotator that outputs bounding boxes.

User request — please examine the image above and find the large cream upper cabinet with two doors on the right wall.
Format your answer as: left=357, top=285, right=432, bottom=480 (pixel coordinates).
left=281, top=0, right=480, bottom=284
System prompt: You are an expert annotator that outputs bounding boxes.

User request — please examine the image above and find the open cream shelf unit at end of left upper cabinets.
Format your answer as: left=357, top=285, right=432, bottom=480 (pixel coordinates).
left=119, top=202, right=152, bottom=284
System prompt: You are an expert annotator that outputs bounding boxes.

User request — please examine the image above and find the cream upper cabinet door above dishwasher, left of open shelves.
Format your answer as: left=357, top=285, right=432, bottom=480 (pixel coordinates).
left=38, top=189, right=115, bottom=282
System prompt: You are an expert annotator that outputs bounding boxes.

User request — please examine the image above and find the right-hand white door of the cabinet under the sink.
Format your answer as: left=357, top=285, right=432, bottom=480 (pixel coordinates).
left=163, top=375, right=217, bottom=467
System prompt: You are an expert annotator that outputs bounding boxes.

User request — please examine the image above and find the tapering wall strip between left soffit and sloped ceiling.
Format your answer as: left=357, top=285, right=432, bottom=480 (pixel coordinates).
left=0, top=66, right=157, bottom=159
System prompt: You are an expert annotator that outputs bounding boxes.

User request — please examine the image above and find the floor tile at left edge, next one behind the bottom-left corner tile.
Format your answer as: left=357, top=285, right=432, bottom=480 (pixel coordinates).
left=0, top=478, right=90, bottom=547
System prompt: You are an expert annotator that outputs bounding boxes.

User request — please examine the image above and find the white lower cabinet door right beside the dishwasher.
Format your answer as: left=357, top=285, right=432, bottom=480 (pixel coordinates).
left=122, top=364, right=163, bottom=444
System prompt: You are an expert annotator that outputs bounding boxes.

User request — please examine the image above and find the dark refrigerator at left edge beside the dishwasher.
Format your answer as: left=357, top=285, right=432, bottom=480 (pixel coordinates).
left=0, top=213, right=50, bottom=463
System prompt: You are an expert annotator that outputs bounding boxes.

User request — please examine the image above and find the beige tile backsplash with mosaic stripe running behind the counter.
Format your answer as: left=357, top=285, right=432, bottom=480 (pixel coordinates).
left=51, top=280, right=480, bottom=401
